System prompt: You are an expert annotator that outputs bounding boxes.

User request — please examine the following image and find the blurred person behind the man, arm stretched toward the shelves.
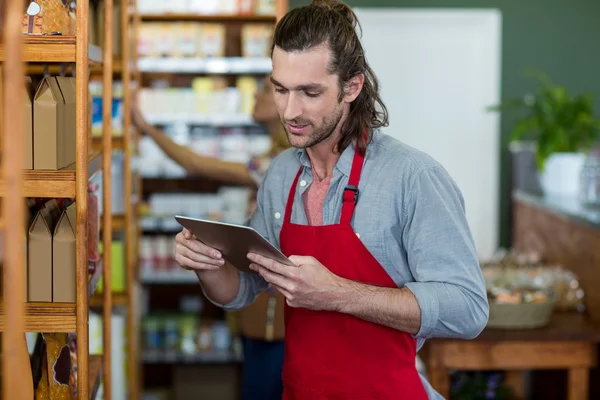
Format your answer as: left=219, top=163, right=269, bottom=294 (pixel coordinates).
left=132, top=79, right=289, bottom=400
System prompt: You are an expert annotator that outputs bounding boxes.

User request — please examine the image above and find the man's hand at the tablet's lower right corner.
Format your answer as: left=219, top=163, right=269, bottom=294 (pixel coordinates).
left=248, top=253, right=343, bottom=311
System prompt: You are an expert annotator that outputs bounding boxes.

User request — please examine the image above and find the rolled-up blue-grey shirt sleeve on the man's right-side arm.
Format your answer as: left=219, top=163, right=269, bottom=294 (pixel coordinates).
left=402, top=166, right=489, bottom=339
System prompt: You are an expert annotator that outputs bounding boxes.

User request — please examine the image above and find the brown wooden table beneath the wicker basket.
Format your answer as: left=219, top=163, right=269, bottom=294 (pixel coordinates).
left=424, top=313, right=600, bottom=400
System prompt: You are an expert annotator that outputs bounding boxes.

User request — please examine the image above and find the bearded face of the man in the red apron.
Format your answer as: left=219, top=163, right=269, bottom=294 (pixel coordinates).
left=271, top=45, right=346, bottom=148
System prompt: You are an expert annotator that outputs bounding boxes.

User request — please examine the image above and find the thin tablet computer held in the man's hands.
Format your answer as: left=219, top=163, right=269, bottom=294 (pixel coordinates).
left=175, top=215, right=294, bottom=272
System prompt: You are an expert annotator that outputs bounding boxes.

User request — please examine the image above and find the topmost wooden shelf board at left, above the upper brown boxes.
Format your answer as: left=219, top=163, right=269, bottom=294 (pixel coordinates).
left=0, top=36, right=102, bottom=64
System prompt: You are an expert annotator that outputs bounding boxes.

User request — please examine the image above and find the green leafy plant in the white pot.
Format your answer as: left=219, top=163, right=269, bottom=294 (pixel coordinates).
left=489, top=72, right=600, bottom=171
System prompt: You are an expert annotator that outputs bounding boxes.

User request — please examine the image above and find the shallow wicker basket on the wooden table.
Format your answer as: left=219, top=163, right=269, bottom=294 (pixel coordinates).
left=487, top=301, right=553, bottom=329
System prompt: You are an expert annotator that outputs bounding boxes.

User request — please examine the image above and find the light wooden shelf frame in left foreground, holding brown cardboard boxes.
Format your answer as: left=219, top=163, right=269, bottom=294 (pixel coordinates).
left=0, top=0, right=113, bottom=399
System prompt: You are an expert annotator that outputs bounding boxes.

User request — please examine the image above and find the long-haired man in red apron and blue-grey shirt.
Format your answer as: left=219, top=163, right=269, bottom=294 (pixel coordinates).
left=176, top=1, right=488, bottom=400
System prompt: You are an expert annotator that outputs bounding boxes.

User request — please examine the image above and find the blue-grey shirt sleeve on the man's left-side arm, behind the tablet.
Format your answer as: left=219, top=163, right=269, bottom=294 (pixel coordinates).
left=202, top=166, right=271, bottom=310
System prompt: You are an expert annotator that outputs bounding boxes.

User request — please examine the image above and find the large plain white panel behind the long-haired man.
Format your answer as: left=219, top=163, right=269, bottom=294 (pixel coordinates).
left=355, top=8, right=501, bottom=257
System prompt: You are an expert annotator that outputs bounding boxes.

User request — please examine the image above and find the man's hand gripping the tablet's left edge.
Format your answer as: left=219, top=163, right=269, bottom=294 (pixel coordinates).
left=175, top=228, right=225, bottom=271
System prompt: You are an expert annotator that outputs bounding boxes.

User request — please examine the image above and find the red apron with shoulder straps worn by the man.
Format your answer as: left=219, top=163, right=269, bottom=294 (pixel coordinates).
left=280, top=148, right=427, bottom=400
